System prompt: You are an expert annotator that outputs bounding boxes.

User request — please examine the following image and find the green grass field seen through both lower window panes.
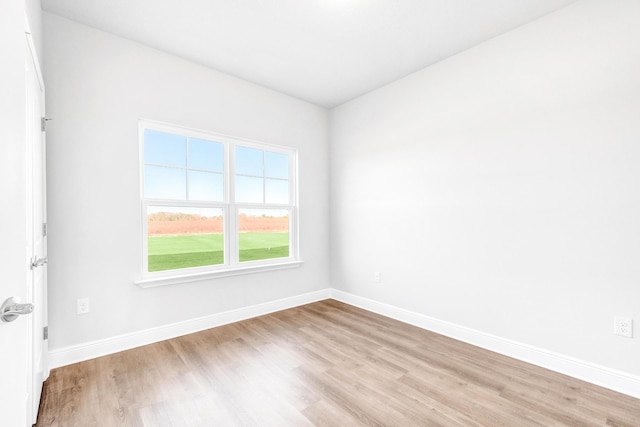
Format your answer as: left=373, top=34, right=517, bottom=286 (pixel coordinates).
left=148, top=233, right=289, bottom=272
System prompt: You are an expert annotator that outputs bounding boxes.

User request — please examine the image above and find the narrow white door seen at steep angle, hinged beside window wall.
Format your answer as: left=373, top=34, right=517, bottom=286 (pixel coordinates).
left=26, top=35, right=49, bottom=424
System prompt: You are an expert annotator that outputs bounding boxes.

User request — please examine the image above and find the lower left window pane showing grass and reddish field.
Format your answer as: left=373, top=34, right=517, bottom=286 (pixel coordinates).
left=147, top=206, right=224, bottom=272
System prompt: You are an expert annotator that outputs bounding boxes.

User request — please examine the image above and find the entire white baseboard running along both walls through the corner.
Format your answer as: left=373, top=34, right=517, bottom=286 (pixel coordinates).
left=49, top=288, right=640, bottom=398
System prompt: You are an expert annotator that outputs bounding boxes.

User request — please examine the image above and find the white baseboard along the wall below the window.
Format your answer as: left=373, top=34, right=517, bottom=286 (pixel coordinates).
left=49, top=289, right=331, bottom=369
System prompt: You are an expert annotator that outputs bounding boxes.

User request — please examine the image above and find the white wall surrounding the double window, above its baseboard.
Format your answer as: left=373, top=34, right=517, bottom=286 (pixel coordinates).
left=44, top=13, right=329, bottom=351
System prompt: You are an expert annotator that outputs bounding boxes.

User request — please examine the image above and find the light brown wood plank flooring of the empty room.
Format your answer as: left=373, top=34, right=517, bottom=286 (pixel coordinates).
left=37, top=300, right=640, bottom=427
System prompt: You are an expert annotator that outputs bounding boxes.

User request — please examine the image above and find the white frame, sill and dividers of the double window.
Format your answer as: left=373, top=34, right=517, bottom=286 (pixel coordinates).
left=135, top=119, right=303, bottom=287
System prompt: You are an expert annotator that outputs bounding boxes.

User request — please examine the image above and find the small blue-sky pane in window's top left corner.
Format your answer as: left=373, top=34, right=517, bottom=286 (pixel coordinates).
left=144, top=129, right=187, bottom=167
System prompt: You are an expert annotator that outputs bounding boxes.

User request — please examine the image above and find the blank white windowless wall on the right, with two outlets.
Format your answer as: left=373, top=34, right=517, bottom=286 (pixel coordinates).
left=330, top=0, right=640, bottom=375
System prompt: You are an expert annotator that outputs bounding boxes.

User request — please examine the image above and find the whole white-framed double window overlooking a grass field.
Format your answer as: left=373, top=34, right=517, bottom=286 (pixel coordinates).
left=138, top=121, right=299, bottom=283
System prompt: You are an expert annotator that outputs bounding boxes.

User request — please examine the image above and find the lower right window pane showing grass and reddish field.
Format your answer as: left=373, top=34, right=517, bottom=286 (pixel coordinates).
left=238, top=209, right=289, bottom=262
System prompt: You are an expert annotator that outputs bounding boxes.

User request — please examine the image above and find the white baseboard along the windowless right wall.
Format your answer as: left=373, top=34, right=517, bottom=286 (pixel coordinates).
left=331, top=289, right=640, bottom=399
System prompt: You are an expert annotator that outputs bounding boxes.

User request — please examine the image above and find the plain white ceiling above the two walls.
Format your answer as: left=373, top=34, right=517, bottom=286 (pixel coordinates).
left=42, top=0, right=576, bottom=108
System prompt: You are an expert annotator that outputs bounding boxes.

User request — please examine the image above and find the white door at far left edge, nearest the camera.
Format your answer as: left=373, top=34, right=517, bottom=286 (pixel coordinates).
left=0, top=13, right=33, bottom=427
